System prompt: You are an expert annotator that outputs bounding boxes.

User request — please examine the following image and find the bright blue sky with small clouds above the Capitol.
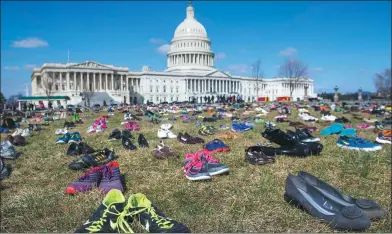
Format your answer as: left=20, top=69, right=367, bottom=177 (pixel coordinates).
left=1, top=1, right=391, bottom=96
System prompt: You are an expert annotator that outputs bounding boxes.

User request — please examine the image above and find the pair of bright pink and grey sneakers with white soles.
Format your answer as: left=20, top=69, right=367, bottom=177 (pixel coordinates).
left=184, top=150, right=229, bottom=180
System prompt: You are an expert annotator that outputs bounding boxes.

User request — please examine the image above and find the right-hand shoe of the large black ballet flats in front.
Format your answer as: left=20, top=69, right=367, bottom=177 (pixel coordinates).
left=298, top=171, right=386, bottom=219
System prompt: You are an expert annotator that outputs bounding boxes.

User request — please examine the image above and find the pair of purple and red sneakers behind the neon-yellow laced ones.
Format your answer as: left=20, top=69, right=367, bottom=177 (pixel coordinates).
left=65, top=161, right=124, bottom=194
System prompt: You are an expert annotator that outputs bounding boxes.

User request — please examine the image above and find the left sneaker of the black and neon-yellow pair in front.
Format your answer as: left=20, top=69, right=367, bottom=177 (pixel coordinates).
left=75, top=189, right=133, bottom=233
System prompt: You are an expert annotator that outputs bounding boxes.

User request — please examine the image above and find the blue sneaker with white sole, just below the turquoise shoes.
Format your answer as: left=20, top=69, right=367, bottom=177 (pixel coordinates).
left=336, top=136, right=382, bottom=151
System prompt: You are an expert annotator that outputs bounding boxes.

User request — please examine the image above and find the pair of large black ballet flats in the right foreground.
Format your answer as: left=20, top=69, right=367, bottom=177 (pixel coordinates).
left=284, top=171, right=386, bottom=230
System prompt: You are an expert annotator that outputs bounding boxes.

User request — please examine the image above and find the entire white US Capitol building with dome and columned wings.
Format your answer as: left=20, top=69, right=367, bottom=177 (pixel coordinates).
left=31, top=2, right=314, bottom=105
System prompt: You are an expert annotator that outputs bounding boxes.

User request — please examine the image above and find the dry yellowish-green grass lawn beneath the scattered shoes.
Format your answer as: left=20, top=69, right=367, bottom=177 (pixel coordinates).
left=1, top=111, right=391, bottom=233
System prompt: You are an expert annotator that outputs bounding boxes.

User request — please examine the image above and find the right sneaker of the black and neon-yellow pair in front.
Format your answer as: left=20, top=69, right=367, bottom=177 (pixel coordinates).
left=124, top=193, right=190, bottom=233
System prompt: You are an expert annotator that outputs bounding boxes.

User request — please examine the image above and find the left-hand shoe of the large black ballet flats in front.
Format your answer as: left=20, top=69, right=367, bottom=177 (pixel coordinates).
left=284, top=174, right=370, bottom=230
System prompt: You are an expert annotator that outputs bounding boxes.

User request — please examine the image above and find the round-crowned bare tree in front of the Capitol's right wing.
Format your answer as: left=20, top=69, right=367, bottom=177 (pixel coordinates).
left=279, top=59, right=308, bottom=101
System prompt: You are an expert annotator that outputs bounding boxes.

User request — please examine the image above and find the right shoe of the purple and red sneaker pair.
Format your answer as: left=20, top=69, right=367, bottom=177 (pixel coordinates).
left=99, top=161, right=124, bottom=193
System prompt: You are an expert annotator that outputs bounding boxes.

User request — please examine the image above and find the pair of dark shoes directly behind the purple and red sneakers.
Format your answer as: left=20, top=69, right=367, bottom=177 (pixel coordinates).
left=68, top=148, right=116, bottom=170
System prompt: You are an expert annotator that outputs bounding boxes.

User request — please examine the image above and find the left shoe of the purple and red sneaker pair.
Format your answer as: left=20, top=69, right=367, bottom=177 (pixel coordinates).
left=65, top=166, right=102, bottom=194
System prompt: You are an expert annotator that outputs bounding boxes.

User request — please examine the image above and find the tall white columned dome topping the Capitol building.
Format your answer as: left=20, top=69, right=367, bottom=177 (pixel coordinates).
left=166, top=1, right=215, bottom=71
